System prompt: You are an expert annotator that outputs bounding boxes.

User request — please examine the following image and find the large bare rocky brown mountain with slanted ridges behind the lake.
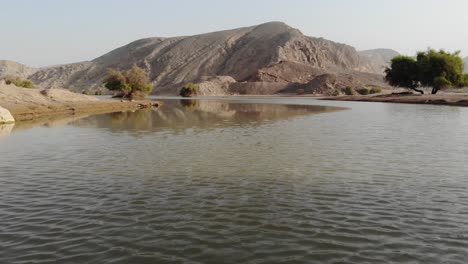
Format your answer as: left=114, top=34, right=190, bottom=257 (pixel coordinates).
left=1, top=22, right=391, bottom=95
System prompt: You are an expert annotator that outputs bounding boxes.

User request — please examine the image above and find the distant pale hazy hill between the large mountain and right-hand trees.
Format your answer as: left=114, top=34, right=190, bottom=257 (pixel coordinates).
left=359, top=49, right=400, bottom=74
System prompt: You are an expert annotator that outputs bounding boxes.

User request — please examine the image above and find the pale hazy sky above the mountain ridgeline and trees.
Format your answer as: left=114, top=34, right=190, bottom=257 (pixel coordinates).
left=0, top=0, right=468, bottom=66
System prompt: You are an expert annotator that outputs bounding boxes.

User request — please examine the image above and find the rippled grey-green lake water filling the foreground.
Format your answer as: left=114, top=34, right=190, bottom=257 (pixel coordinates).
left=0, top=98, right=468, bottom=264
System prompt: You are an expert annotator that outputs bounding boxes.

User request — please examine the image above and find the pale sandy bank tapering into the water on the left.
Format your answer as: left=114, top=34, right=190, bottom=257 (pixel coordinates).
left=0, top=83, right=159, bottom=121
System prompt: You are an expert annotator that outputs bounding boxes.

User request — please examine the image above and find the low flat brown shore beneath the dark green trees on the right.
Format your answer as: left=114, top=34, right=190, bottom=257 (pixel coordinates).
left=320, top=93, right=468, bottom=106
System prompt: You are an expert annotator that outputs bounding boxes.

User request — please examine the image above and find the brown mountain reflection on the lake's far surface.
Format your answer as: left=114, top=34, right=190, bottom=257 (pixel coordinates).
left=71, top=100, right=342, bottom=133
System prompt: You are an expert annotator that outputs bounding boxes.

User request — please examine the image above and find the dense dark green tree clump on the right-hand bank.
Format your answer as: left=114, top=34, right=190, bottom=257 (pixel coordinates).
left=385, top=49, right=468, bottom=94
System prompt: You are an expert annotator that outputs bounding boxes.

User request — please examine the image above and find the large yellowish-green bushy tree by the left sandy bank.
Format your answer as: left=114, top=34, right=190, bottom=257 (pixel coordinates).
left=104, top=65, right=153, bottom=97
